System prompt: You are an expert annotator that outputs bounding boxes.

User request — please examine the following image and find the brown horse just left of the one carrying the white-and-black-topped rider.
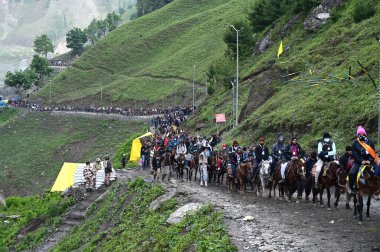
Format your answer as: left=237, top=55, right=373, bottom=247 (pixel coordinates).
left=285, top=159, right=306, bottom=202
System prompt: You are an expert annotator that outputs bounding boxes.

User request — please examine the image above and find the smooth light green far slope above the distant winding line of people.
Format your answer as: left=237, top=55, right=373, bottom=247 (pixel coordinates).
left=37, top=0, right=251, bottom=104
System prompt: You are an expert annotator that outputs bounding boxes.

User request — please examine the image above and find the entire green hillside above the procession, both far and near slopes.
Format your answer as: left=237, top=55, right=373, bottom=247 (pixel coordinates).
left=36, top=0, right=380, bottom=150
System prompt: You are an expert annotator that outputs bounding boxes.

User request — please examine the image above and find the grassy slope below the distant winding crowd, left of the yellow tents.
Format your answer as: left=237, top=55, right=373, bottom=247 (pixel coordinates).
left=0, top=110, right=143, bottom=196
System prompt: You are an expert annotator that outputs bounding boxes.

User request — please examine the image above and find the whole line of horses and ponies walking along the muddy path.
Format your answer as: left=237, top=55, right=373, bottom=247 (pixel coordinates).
left=174, top=153, right=380, bottom=224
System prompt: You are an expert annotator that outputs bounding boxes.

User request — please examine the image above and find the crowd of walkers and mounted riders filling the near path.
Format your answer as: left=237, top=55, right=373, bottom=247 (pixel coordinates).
left=132, top=114, right=380, bottom=202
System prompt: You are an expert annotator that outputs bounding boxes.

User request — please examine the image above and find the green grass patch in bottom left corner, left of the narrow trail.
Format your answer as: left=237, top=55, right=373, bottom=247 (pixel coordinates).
left=0, top=193, right=74, bottom=251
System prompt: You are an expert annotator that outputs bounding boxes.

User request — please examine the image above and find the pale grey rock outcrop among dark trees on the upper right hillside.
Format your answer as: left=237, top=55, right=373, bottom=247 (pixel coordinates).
left=303, top=0, right=344, bottom=31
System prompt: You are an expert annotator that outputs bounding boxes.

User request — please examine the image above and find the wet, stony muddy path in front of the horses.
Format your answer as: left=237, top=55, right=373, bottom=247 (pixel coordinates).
left=134, top=168, right=380, bottom=251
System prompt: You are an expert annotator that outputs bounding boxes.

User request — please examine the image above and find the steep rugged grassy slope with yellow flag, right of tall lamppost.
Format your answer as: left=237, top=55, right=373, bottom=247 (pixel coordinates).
left=189, top=1, right=380, bottom=152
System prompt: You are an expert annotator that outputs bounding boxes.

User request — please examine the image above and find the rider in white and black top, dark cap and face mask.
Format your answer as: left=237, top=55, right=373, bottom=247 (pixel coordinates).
left=314, top=132, right=336, bottom=188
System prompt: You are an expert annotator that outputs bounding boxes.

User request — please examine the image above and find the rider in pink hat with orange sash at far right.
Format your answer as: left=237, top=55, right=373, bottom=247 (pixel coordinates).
left=349, top=126, right=379, bottom=193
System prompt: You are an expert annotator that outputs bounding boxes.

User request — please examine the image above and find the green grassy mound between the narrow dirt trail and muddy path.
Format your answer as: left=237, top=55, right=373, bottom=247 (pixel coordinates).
left=53, top=178, right=236, bottom=251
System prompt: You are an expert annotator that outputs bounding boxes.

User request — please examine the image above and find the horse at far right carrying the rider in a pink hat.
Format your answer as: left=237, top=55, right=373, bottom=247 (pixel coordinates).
left=353, top=165, right=380, bottom=225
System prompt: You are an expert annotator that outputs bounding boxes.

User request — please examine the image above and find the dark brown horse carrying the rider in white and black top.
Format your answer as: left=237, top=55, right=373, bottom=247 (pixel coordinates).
left=312, top=161, right=345, bottom=211
